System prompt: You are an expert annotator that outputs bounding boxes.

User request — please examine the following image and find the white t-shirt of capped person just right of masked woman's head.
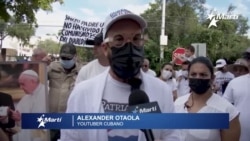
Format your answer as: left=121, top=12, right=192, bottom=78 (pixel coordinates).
left=214, top=71, right=234, bottom=95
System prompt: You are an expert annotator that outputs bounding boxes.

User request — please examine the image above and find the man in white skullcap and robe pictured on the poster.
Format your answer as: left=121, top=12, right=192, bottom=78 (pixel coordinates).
left=13, top=70, right=47, bottom=141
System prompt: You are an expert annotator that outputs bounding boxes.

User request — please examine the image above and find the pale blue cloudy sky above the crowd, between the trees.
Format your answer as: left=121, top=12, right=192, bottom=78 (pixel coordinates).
left=36, top=0, right=250, bottom=37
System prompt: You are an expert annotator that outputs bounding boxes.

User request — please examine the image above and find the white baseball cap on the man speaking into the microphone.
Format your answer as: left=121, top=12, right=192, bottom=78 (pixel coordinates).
left=103, top=9, right=147, bottom=39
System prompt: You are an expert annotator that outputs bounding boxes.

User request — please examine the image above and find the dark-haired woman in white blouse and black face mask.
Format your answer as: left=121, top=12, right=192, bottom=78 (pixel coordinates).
left=175, top=57, right=240, bottom=141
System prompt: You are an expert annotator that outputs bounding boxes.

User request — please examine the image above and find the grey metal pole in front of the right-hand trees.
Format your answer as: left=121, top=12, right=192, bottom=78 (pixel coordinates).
left=160, top=0, right=166, bottom=61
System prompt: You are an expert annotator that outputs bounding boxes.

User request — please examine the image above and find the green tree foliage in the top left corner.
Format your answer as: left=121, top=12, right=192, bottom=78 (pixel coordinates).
left=0, top=0, right=63, bottom=23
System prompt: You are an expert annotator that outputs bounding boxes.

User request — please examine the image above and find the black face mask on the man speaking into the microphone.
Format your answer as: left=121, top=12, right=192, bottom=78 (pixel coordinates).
left=109, top=43, right=144, bottom=80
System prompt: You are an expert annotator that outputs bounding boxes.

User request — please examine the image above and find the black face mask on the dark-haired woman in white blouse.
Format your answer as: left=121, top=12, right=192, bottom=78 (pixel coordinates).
left=189, top=78, right=211, bottom=94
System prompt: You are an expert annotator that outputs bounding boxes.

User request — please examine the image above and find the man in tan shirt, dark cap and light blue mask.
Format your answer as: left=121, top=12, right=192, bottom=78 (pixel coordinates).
left=48, top=43, right=80, bottom=141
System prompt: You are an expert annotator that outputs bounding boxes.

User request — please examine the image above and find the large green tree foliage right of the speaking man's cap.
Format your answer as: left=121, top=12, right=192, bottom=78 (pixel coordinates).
left=141, top=0, right=250, bottom=70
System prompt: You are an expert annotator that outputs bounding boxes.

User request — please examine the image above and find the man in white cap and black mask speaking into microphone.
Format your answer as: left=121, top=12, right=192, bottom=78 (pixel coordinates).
left=61, top=9, right=179, bottom=141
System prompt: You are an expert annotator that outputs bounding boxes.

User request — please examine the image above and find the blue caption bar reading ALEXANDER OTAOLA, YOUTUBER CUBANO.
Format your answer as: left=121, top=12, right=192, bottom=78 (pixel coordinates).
left=22, top=113, right=229, bottom=129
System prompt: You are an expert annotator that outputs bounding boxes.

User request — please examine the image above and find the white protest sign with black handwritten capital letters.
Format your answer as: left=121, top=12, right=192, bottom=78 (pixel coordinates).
left=60, top=15, right=104, bottom=47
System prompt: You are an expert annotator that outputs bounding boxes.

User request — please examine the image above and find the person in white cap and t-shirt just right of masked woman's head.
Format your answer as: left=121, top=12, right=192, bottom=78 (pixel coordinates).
left=214, top=59, right=234, bottom=95
